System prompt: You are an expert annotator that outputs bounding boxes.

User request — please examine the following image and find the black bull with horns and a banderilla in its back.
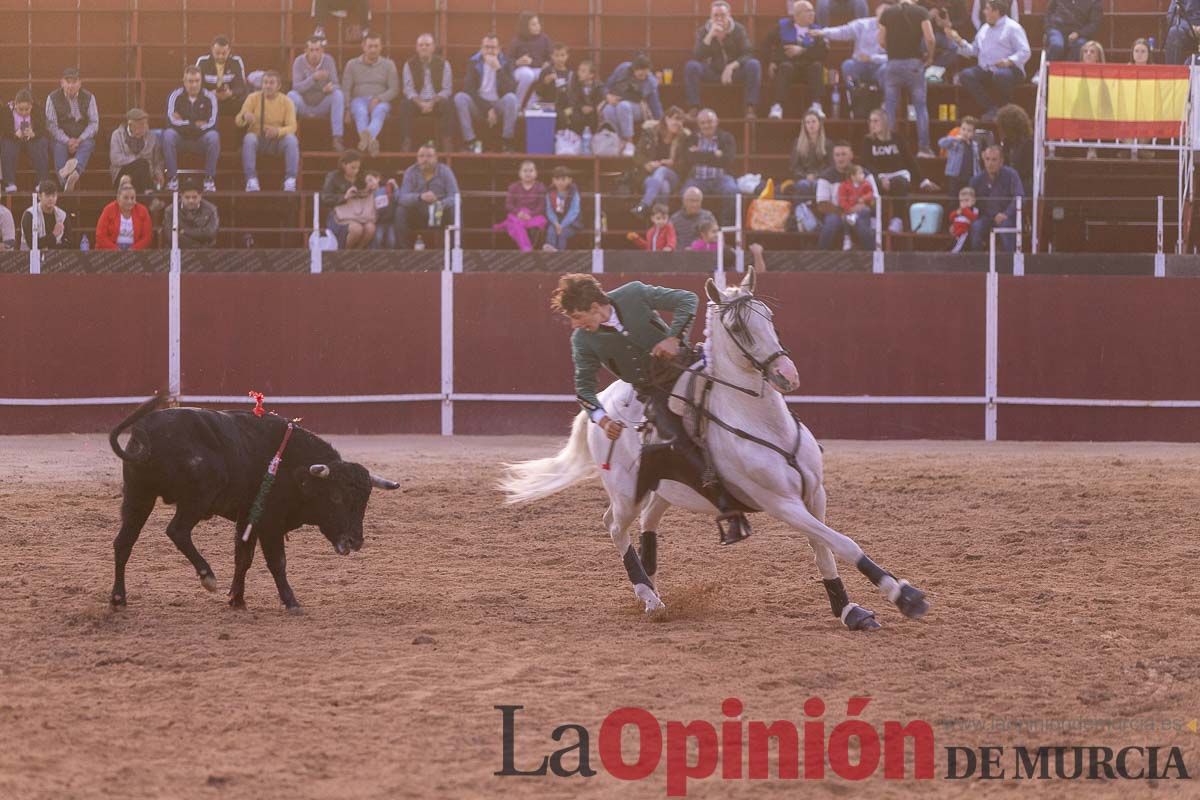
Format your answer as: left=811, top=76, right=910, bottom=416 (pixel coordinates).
left=108, top=397, right=400, bottom=609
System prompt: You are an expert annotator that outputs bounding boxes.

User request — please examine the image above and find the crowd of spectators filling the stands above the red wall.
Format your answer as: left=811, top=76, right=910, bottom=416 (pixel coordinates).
left=0, top=0, right=1180, bottom=256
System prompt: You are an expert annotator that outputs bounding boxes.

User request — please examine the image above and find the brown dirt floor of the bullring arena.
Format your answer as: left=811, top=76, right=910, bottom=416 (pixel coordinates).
left=0, top=437, right=1200, bottom=800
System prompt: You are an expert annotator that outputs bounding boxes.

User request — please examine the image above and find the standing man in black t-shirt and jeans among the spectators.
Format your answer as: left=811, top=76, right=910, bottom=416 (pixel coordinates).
left=880, top=0, right=936, bottom=157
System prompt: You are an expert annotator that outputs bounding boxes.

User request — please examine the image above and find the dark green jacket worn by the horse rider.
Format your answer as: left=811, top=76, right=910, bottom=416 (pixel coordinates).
left=571, top=281, right=700, bottom=414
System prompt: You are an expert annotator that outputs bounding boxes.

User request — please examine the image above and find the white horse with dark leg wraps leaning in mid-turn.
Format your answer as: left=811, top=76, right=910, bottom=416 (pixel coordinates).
left=500, top=269, right=929, bottom=630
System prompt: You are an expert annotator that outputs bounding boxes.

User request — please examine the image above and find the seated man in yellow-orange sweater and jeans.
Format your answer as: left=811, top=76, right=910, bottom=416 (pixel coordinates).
left=235, top=70, right=300, bottom=192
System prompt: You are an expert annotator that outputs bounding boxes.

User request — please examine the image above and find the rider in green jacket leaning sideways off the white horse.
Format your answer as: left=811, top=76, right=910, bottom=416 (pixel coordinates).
left=551, top=273, right=750, bottom=545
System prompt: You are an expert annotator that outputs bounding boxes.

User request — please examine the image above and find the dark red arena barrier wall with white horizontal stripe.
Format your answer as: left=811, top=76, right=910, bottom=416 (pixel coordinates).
left=0, top=272, right=1200, bottom=441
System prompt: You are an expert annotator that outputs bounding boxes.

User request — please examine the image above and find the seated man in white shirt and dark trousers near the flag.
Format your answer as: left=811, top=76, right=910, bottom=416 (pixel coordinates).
left=947, top=0, right=1030, bottom=122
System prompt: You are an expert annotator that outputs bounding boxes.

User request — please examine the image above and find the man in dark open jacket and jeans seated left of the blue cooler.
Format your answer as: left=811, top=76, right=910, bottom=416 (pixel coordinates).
left=454, top=34, right=518, bottom=152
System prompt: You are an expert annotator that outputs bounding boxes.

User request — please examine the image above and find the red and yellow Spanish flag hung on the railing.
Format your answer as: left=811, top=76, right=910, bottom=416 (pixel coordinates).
left=1046, top=61, right=1188, bottom=139
